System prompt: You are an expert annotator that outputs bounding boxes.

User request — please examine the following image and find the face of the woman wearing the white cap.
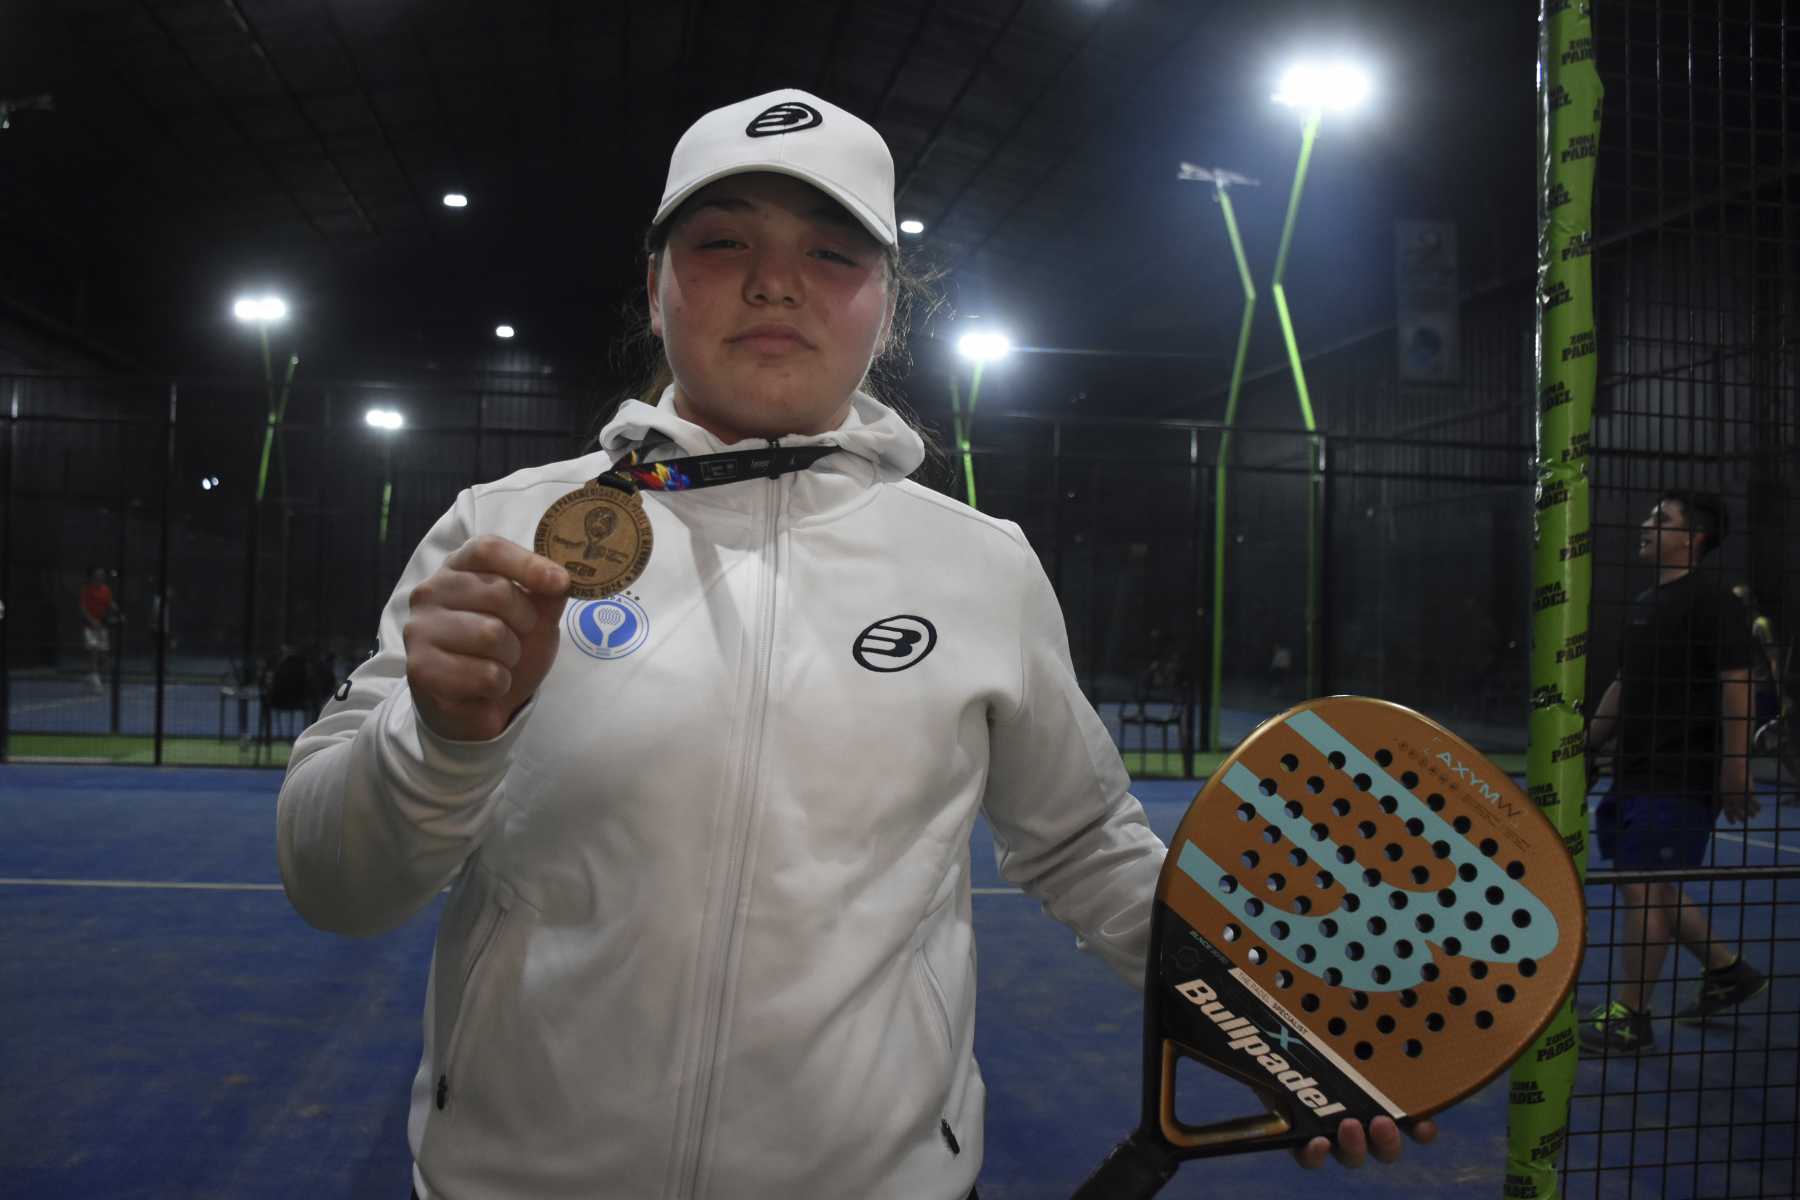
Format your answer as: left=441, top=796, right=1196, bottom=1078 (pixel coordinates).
left=648, top=173, right=889, bottom=443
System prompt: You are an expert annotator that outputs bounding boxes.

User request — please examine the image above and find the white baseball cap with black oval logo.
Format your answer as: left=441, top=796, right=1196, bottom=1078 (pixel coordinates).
left=653, top=88, right=895, bottom=246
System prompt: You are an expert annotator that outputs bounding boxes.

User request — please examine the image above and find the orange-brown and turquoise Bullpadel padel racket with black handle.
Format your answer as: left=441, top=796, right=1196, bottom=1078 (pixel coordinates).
left=1076, top=696, right=1586, bottom=1200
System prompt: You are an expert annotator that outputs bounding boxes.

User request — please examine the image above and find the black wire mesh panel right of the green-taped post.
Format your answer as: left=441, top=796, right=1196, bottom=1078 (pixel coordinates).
left=1564, top=0, right=1800, bottom=1196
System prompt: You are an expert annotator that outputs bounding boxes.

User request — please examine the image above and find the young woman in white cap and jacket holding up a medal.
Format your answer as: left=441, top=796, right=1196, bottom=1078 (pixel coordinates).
left=279, top=92, right=1429, bottom=1200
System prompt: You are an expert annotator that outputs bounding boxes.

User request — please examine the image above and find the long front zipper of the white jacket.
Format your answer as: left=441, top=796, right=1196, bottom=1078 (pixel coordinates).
left=677, top=455, right=781, bottom=1196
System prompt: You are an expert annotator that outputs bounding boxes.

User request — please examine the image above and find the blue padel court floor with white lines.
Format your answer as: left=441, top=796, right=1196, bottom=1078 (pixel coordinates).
left=0, top=765, right=1800, bottom=1200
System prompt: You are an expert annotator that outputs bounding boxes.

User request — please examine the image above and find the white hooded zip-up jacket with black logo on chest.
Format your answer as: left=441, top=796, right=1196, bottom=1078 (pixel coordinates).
left=279, top=392, right=1163, bottom=1200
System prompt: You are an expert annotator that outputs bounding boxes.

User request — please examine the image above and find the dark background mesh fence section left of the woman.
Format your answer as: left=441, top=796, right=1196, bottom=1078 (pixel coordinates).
left=0, top=376, right=598, bottom=765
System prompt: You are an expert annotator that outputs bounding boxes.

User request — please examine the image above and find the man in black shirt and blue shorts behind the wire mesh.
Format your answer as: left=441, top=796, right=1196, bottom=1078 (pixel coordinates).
left=1580, top=493, right=1768, bottom=1054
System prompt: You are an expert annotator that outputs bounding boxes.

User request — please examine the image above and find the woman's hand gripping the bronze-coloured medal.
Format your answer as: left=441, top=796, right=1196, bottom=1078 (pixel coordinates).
left=403, top=534, right=569, bottom=741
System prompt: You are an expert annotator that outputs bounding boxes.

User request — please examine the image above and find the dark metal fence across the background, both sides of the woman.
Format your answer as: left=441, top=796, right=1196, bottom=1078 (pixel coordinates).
left=0, top=354, right=1528, bottom=775
